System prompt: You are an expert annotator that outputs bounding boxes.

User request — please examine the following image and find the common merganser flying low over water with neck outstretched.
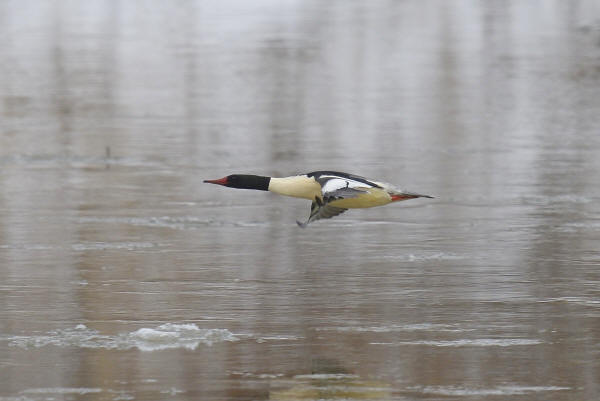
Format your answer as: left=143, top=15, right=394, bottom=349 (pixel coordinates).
left=204, top=171, right=433, bottom=227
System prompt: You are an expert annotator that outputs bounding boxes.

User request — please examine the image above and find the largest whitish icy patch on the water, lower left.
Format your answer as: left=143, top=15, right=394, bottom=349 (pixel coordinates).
left=3, top=323, right=238, bottom=351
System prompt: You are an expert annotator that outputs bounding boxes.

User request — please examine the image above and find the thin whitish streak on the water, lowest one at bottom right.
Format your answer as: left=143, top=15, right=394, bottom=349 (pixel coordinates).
left=409, top=385, right=571, bottom=396
